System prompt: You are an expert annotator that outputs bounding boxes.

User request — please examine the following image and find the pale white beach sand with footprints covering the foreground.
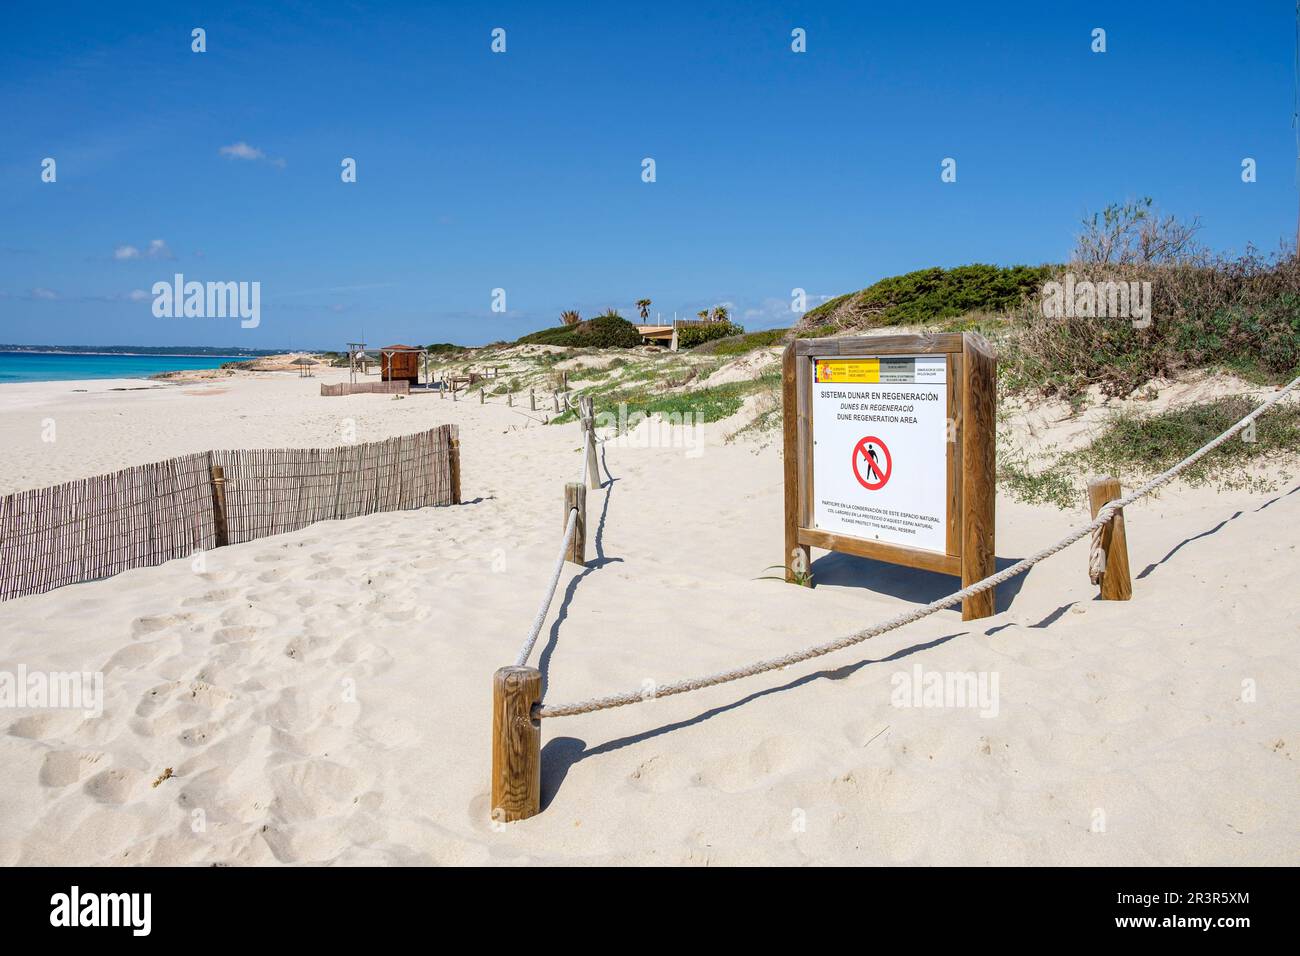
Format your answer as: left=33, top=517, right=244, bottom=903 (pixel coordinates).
left=0, top=371, right=1300, bottom=865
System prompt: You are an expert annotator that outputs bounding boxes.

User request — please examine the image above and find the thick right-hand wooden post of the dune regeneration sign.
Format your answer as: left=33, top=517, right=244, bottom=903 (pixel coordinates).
left=961, top=333, right=997, bottom=620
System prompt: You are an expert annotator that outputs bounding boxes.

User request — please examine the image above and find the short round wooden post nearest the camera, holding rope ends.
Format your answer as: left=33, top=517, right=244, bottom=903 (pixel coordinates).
left=491, top=667, right=542, bottom=823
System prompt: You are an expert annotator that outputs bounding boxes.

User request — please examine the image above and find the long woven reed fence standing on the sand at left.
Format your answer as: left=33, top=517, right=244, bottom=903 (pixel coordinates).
left=0, top=425, right=460, bottom=601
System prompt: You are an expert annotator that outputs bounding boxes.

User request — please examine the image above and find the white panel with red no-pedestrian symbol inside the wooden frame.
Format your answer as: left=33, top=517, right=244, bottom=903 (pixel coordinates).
left=813, top=355, right=949, bottom=553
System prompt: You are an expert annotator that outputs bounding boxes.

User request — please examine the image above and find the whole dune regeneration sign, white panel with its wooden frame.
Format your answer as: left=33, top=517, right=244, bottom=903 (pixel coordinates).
left=783, top=332, right=997, bottom=620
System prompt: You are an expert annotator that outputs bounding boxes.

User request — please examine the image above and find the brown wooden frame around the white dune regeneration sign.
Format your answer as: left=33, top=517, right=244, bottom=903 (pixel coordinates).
left=781, top=332, right=997, bottom=620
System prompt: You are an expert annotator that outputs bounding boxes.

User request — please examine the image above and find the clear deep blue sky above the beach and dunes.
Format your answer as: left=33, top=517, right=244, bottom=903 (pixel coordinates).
left=0, top=0, right=1296, bottom=349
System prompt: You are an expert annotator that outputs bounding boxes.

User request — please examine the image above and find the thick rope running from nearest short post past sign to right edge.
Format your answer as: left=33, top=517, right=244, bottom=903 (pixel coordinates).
left=534, top=377, right=1300, bottom=717
